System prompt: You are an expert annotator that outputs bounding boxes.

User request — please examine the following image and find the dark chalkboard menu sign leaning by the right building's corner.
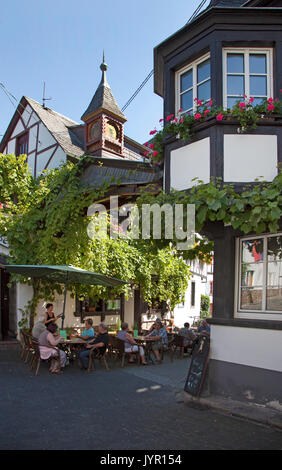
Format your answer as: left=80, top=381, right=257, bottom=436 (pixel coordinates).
left=184, top=336, right=210, bottom=397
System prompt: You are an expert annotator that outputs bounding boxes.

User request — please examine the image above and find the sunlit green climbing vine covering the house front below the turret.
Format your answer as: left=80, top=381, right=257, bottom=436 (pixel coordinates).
left=0, top=155, right=192, bottom=326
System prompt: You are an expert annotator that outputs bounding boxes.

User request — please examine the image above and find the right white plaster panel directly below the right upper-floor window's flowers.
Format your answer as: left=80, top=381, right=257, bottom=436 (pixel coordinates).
left=224, top=135, right=278, bottom=182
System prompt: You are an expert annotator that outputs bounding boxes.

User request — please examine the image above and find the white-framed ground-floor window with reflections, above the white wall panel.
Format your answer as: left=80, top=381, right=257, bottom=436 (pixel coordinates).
left=238, top=233, right=282, bottom=314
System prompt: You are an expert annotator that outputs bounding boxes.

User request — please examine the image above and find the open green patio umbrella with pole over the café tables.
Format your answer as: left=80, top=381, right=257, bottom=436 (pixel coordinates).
left=5, top=264, right=129, bottom=328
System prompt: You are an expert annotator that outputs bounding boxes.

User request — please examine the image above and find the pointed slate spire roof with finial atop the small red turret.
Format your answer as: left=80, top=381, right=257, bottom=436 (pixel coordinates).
left=81, top=51, right=126, bottom=121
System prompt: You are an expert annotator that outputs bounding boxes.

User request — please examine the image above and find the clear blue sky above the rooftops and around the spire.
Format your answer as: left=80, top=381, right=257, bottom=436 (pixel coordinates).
left=0, top=0, right=205, bottom=143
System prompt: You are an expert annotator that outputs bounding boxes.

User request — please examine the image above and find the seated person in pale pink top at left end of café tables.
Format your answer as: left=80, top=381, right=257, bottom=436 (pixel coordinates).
left=38, top=323, right=67, bottom=374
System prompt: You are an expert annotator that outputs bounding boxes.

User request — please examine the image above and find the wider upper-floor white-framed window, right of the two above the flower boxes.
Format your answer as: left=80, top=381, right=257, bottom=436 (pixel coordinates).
left=223, top=48, right=273, bottom=108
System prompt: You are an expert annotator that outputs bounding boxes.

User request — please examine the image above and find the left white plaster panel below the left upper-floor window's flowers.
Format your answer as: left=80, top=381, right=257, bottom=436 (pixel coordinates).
left=170, top=137, right=210, bottom=190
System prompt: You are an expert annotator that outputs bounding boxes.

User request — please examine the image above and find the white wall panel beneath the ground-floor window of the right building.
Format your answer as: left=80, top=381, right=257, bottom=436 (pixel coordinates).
left=210, top=325, right=282, bottom=372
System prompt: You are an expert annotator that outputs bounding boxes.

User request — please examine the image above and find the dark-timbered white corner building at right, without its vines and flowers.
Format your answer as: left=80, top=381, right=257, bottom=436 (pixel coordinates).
left=154, top=0, right=282, bottom=404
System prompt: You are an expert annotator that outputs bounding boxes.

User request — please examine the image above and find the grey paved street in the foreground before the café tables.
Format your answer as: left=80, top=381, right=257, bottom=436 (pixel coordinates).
left=0, top=349, right=282, bottom=450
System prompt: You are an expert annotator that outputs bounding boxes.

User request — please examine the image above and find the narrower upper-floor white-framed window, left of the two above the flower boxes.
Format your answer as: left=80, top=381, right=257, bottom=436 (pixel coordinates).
left=175, top=55, right=211, bottom=114
